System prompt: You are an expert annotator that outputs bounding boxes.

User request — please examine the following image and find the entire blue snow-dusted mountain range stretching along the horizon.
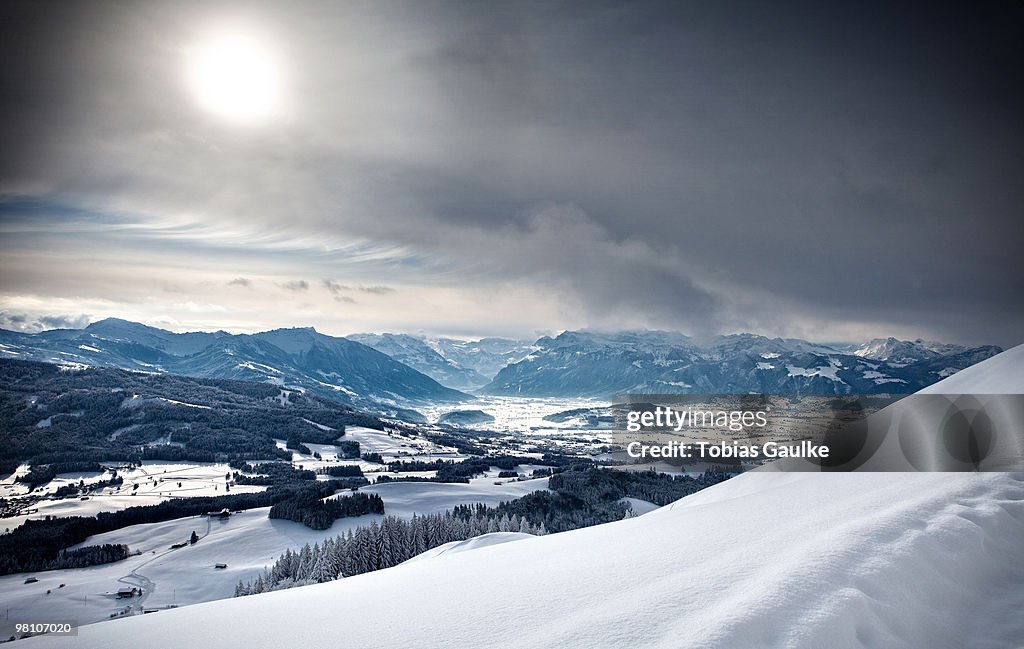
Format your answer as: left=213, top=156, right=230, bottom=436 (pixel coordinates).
left=0, top=318, right=1001, bottom=399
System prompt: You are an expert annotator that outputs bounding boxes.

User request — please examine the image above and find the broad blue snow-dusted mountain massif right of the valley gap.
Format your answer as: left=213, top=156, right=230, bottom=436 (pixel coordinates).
left=481, top=331, right=999, bottom=398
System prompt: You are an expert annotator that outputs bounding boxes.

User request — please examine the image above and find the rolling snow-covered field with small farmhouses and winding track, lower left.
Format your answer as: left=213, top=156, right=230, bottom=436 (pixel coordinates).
left=0, top=478, right=547, bottom=638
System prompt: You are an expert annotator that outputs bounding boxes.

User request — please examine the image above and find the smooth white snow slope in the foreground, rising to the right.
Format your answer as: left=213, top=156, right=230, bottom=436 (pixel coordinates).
left=25, top=348, right=1024, bottom=649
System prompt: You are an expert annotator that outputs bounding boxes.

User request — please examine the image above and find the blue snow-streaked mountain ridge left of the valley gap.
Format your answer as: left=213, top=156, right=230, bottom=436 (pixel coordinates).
left=0, top=318, right=468, bottom=405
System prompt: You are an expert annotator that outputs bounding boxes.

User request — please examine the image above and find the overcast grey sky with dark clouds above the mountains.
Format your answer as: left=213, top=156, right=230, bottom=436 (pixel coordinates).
left=0, top=0, right=1024, bottom=346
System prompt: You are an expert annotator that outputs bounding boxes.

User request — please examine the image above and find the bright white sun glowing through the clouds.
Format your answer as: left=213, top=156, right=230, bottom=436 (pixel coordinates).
left=186, top=35, right=281, bottom=124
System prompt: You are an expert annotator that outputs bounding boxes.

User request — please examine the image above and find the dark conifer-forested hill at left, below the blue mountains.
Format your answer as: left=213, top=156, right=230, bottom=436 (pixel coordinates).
left=0, top=358, right=383, bottom=464
